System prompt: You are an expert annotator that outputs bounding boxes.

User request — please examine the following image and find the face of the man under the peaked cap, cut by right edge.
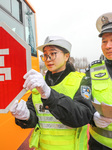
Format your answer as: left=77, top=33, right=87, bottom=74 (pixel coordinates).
left=101, top=33, right=112, bottom=60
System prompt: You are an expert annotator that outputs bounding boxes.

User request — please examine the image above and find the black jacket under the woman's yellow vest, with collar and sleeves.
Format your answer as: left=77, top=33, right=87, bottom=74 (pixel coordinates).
left=15, top=62, right=95, bottom=128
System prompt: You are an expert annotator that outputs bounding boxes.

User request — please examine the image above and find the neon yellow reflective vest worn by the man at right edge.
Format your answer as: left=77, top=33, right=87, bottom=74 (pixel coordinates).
left=89, top=61, right=112, bottom=148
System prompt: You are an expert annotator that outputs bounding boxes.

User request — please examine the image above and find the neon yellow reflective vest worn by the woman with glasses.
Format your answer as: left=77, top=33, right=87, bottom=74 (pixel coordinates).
left=30, top=72, right=87, bottom=150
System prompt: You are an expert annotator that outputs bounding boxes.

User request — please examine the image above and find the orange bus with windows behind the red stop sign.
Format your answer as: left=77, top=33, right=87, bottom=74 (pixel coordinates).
left=0, top=0, right=39, bottom=150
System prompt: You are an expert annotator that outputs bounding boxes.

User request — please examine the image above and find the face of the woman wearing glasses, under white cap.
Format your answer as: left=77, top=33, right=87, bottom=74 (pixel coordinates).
left=43, top=46, right=69, bottom=73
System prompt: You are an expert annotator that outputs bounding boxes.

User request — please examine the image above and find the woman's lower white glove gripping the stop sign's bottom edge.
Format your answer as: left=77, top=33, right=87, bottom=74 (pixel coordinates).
left=10, top=100, right=30, bottom=120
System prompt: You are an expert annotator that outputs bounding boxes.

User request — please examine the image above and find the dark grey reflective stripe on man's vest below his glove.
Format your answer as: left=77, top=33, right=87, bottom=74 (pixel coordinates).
left=91, top=126, right=112, bottom=138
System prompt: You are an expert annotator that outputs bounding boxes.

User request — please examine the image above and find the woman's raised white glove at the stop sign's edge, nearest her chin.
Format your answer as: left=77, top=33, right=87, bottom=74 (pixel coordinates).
left=23, top=69, right=51, bottom=99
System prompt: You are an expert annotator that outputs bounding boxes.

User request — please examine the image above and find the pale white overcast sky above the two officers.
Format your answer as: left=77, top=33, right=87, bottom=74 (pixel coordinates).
left=28, top=0, right=112, bottom=62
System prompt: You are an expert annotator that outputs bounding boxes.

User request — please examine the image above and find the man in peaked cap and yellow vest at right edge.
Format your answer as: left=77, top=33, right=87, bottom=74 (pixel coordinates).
left=89, top=13, right=112, bottom=150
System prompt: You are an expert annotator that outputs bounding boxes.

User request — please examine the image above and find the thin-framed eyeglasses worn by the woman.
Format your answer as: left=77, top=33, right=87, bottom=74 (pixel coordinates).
left=40, top=52, right=62, bottom=62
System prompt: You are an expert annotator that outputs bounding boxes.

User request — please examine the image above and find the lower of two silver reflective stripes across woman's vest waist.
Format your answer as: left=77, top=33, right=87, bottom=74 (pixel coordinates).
left=39, top=123, right=72, bottom=129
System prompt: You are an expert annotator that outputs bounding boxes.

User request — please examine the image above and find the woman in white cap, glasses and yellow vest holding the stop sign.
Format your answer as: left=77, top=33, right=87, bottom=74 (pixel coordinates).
left=10, top=36, right=94, bottom=150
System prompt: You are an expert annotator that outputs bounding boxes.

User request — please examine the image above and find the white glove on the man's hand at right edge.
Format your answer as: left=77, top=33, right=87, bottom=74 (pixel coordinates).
left=93, top=112, right=112, bottom=128
